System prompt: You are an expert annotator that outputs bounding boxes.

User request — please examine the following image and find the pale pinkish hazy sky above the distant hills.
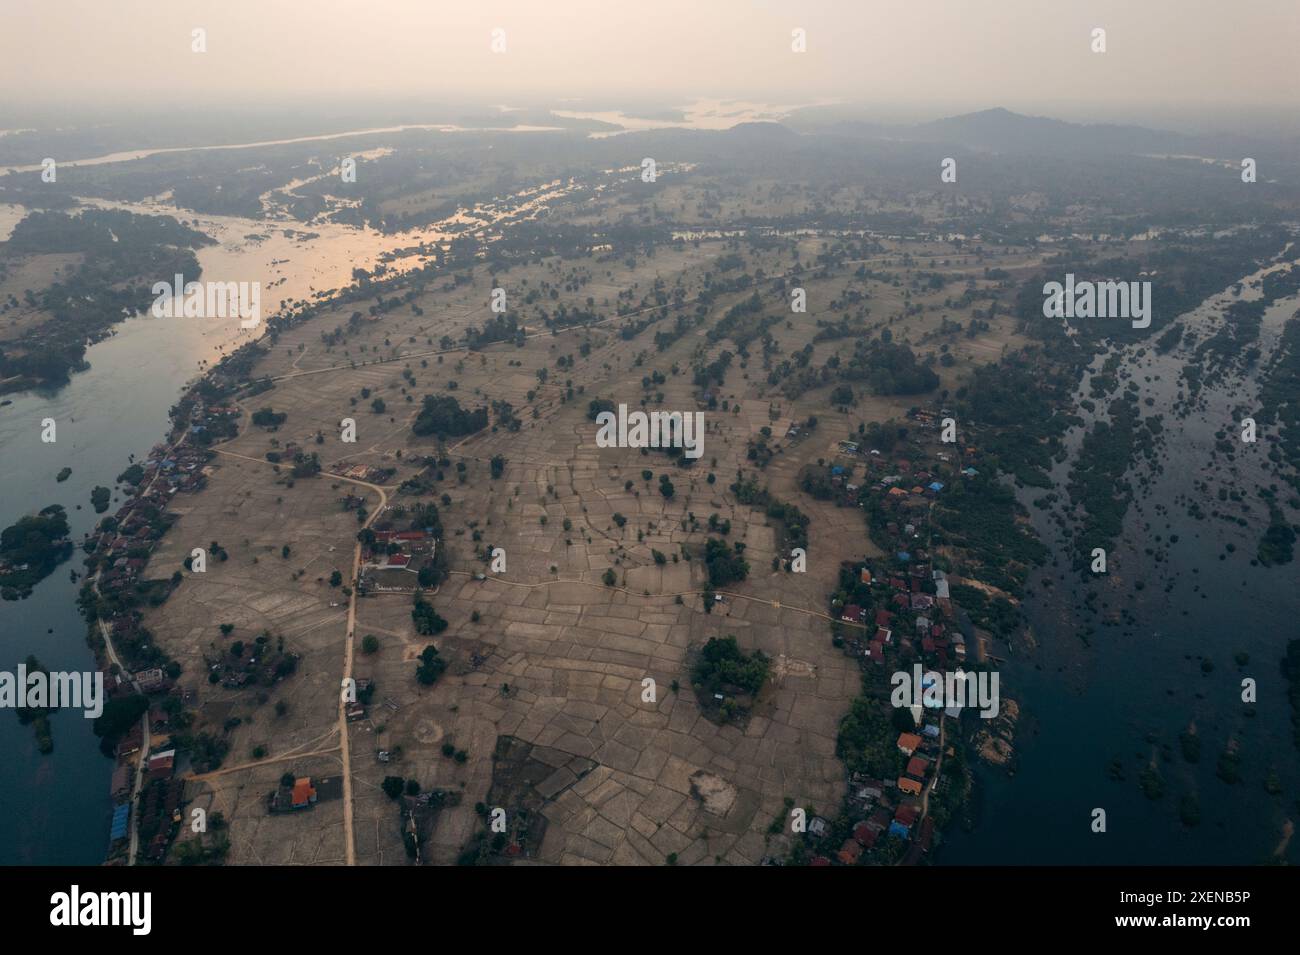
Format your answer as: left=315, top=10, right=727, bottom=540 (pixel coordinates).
left=0, top=0, right=1300, bottom=128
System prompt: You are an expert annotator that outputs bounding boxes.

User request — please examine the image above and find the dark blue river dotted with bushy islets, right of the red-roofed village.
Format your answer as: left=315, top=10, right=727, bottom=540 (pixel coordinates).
left=940, top=252, right=1300, bottom=865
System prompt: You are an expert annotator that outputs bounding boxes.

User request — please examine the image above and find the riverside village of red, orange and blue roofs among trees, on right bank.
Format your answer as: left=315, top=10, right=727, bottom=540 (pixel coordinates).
left=772, top=408, right=1013, bottom=865
